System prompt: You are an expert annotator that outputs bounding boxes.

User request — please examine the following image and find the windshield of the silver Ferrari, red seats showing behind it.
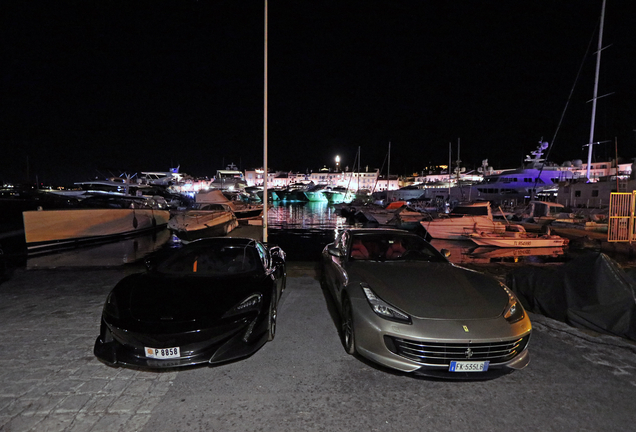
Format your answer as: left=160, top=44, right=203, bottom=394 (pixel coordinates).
left=349, top=233, right=446, bottom=262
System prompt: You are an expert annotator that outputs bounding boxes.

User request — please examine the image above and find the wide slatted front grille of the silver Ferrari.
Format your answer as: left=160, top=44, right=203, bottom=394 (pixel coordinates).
left=384, top=335, right=530, bottom=366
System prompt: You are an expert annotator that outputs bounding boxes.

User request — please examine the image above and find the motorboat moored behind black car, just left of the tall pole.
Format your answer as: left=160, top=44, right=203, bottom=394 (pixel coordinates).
left=168, top=203, right=238, bottom=241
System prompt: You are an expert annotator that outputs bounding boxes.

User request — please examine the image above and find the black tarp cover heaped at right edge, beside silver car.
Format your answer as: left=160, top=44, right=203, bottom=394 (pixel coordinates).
left=507, top=253, right=636, bottom=340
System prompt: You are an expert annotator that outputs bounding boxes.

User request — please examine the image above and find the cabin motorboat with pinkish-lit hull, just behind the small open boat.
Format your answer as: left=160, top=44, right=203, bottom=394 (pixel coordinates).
left=420, top=201, right=506, bottom=240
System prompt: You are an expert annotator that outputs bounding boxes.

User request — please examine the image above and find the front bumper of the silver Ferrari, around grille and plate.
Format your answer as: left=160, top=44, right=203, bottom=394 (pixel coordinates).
left=351, top=297, right=532, bottom=379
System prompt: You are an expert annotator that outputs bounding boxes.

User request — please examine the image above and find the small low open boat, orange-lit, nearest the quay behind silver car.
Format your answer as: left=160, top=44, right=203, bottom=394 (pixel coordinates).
left=466, top=225, right=569, bottom=248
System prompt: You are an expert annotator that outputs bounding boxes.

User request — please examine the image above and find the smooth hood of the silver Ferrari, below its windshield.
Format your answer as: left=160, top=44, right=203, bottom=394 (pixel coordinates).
left=348, top=262, right=508, bottom=320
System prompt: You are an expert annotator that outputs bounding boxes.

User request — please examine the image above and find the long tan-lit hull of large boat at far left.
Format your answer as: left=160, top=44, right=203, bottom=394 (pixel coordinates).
left=22, top=209, right=170, bottom=251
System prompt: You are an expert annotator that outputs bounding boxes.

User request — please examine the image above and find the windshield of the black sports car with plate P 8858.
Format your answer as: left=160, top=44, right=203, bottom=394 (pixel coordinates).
left=156, top=245, right=260, bottom=276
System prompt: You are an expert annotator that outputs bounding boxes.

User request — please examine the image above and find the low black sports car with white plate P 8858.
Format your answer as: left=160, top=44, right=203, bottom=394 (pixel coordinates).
left=94, top=237, right=286, bottom=368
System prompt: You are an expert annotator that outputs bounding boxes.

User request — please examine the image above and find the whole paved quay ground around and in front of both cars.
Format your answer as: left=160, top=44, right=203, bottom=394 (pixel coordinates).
left=0, top=266, right=636, bottom=432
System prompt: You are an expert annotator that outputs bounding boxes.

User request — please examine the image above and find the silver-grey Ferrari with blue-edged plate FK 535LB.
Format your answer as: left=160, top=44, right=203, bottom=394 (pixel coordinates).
left=321, top=228, right=532, bottom=379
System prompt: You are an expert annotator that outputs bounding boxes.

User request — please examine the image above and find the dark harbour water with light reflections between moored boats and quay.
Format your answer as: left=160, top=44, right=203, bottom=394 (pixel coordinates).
left=0, top=203, right=626, bottom=277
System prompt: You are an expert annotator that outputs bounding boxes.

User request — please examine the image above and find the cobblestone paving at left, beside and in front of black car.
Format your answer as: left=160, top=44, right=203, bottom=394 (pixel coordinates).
left=0, top=268, right=176, bottom=431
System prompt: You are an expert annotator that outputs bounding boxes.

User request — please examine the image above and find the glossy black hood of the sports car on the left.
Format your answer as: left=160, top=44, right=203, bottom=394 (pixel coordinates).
left=117, top=273, right=261, bottom=324
